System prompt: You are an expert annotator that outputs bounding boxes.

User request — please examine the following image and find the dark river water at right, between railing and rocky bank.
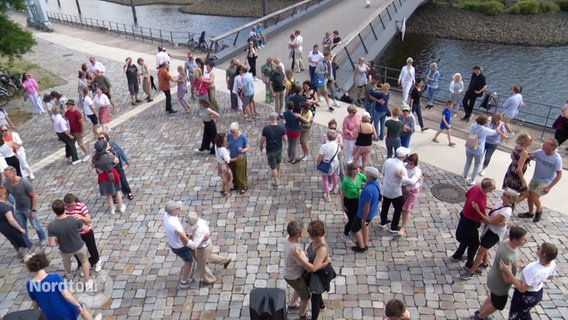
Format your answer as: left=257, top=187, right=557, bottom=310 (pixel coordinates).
left=375, top=34, right=568, bottom=122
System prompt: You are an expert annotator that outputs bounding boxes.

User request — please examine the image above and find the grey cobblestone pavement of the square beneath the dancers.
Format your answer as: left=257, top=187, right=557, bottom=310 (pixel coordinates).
left=0, top=37, right=568, bottom=319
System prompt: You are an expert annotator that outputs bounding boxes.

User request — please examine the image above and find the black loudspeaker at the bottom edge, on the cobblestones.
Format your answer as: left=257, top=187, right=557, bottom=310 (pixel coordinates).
left=250, top=288, right=288, bottom=320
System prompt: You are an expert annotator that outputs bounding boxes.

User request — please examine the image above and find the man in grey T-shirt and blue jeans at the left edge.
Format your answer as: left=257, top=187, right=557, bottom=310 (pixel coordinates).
left=4, top=166, right=47, bottom=250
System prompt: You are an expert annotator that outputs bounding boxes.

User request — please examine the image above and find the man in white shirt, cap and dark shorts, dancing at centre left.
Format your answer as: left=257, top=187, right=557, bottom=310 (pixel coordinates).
left=163, top=201, right=193, bottom=289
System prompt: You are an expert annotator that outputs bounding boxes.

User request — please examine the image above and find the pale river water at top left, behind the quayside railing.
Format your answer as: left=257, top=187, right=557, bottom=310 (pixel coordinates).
left=46, top=0, right=253, bottom=36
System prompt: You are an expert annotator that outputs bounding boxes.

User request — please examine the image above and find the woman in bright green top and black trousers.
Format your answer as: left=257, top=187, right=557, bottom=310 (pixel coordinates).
left=340, top=162, right=367, bottom=241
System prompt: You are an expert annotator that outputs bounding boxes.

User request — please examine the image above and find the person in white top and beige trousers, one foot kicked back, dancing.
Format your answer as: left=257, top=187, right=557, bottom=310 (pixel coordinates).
left=187, top=212, right=232, bottom=284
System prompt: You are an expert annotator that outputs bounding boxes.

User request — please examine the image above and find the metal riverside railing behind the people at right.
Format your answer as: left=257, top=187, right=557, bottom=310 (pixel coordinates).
left=376, top=66, right=560, bottom=139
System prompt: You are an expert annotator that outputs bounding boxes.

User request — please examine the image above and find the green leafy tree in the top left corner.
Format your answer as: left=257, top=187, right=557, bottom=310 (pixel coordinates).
left=0, top=0, right=36, bottom=59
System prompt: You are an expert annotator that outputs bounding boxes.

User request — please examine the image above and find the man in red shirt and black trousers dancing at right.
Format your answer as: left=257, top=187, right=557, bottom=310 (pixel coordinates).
left=451, top=178, right=495, bottom=270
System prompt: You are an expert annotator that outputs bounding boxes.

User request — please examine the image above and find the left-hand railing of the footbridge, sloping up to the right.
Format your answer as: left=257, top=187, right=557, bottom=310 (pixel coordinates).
left=207, top=0, right=330, bottom=59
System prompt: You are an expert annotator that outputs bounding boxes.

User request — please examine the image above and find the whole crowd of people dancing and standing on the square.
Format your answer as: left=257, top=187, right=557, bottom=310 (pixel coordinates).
left=0, top=29, right=568, bottom=319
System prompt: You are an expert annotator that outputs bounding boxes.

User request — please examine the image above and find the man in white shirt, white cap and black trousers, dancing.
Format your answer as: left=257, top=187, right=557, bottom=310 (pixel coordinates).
left=380, top=147, right=410, bottom=233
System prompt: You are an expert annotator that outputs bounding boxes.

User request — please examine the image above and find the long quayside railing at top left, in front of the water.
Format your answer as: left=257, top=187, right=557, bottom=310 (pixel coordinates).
left=43, top=11, right=209, bottom=47
